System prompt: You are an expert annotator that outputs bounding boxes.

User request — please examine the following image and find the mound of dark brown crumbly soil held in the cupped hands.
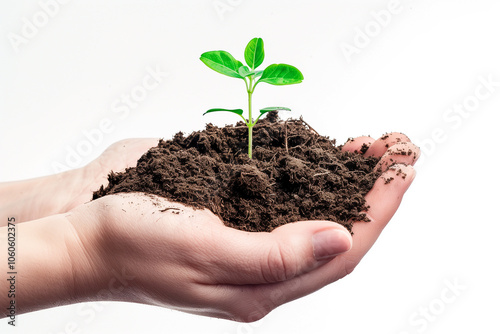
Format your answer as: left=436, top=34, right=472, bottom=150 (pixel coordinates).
left=93, top=112, right=380, bottom=231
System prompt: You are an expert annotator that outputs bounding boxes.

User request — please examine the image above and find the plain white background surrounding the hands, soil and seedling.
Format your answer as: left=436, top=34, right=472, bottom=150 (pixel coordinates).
left=0, top=0, right=500, bottom=334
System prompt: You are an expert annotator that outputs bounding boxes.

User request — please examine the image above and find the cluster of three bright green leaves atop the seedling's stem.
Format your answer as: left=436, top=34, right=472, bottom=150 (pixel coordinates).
left=200, top=38, right=304, bottom=87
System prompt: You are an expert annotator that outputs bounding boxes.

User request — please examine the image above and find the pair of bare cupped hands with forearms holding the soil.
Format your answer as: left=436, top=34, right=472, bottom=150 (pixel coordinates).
left=0, top=133, right=419, bottom=322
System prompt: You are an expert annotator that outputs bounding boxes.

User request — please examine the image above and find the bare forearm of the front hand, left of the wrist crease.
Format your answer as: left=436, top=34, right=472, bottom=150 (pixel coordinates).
left=0, top=215, right=90, bottom=315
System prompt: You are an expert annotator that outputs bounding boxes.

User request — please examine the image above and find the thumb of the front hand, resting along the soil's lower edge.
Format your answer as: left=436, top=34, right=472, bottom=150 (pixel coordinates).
left=203, top=221, right=352, bottom=284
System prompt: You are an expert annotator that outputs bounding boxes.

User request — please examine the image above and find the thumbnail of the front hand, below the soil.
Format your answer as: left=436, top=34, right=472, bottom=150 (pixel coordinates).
left=312, top=229, right=352, bottom=261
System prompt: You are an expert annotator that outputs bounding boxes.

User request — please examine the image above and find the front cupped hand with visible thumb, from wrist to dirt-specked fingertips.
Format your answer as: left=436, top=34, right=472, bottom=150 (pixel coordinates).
left=62, top=133, right=419, bottom=321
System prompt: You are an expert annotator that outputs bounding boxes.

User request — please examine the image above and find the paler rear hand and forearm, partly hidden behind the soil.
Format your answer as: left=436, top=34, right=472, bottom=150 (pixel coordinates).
left=0, top=138, right=158, bottom=226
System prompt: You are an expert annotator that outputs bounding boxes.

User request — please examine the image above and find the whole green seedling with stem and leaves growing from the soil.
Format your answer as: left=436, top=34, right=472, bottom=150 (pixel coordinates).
left=200, top=38, right=304, bottom=159
